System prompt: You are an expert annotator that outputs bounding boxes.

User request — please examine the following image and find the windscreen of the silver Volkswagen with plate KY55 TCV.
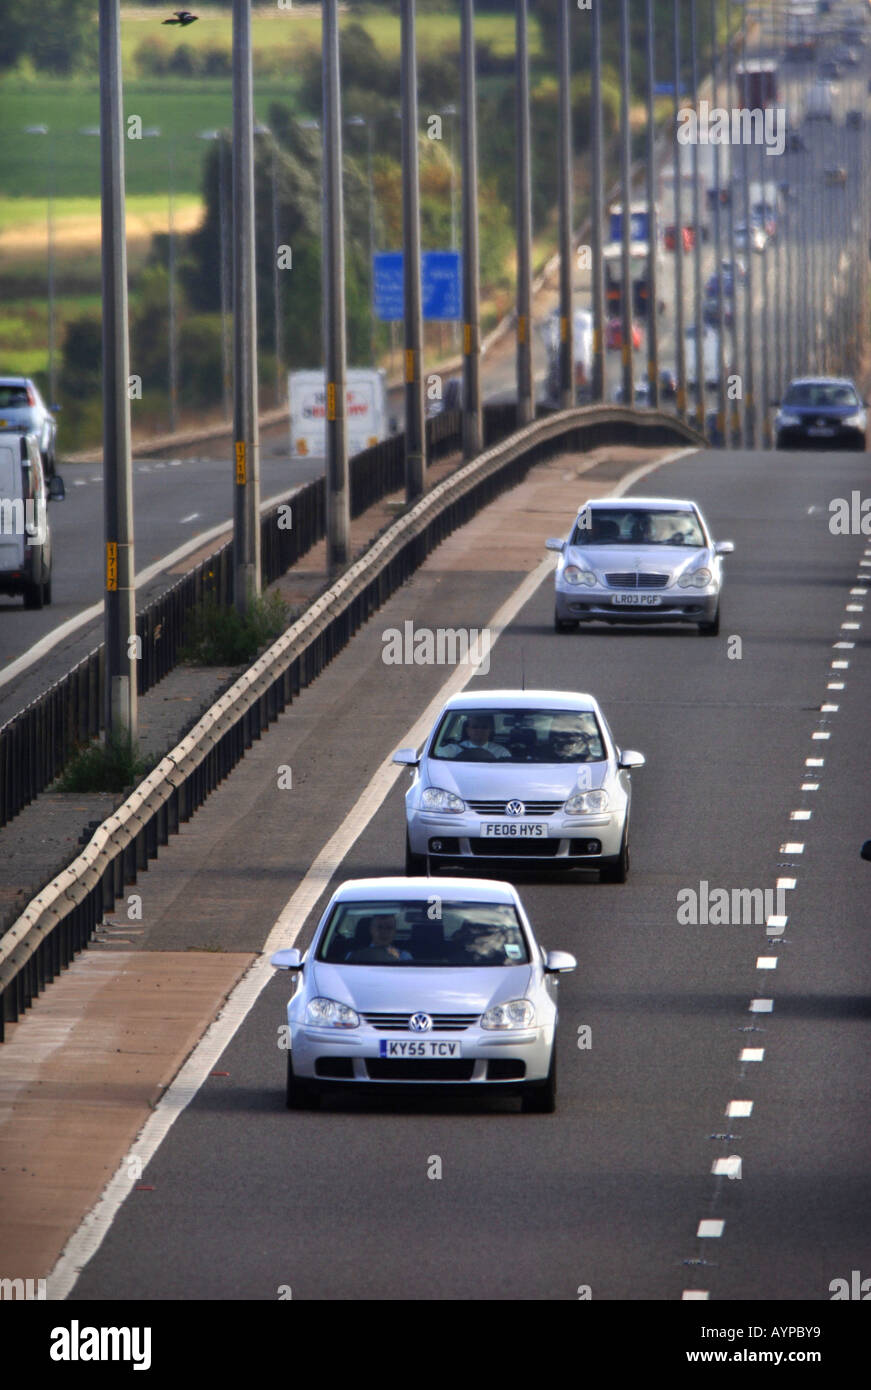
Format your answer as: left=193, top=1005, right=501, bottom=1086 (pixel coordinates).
left=315, top=900, right=529, bottom=967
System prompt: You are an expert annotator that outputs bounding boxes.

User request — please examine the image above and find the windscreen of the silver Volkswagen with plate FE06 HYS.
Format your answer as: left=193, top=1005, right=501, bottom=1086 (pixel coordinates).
left=429, top=709, right=606, bottom=763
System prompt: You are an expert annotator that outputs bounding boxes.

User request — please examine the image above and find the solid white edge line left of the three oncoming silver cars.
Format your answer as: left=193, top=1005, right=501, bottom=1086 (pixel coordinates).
left=46, top=449, right=697, bottom=1300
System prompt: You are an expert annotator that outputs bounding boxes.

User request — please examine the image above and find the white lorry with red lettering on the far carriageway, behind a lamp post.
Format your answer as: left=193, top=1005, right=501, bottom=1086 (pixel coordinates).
left=288, top=367, right=389, bottom=459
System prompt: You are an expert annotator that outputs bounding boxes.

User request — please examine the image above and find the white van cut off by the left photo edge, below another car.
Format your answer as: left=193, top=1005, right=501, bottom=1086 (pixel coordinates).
left=0, top=434, right=65, bottom=609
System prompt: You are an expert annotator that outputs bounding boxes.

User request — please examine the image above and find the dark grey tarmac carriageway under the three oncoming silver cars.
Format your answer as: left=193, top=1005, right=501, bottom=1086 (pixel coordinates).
left=72, top=453, right=871, bottom=1300
